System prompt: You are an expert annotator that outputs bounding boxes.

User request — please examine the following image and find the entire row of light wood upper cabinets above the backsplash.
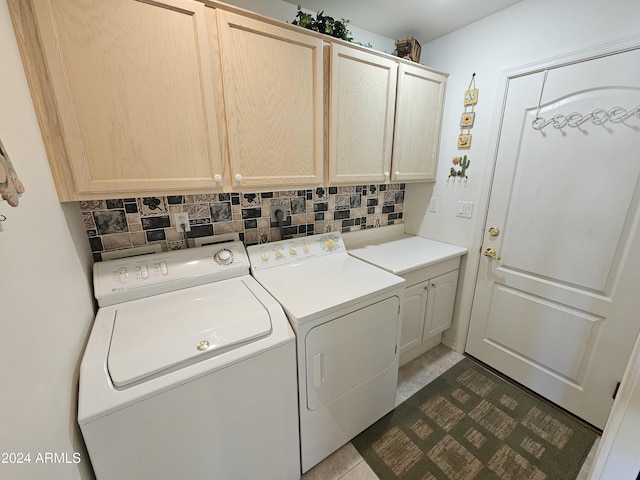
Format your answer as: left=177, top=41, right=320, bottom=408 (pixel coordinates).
left=12, top=0, right=445, bottom=201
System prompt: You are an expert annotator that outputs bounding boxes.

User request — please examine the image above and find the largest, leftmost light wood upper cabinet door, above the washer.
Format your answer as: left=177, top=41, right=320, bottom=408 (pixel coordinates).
left=21, top=0, right=221, bottom=201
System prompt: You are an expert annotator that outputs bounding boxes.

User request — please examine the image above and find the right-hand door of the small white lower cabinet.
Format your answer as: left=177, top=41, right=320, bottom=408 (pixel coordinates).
left=422, top=270, right=458, bottom=340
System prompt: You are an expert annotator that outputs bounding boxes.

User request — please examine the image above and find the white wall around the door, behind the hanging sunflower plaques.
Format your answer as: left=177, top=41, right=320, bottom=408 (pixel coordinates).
left=405, top=0, right=640, bottom=351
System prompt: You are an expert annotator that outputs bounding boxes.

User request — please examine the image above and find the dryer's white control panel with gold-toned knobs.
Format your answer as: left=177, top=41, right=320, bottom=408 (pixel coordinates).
left=247, top=232, right=347, bottom=272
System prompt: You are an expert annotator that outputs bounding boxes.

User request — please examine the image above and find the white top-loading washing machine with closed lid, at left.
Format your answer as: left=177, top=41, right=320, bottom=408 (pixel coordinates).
left=78, top=242, right=300, bottom=480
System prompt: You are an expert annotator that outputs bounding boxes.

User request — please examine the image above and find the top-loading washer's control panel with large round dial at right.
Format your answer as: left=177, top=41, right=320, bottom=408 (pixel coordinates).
left=93, top=241, right=249, bottom=307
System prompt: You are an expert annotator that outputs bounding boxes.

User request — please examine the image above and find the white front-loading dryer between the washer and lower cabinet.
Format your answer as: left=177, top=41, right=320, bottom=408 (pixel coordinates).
left=247, top=233, right=404, bottom=472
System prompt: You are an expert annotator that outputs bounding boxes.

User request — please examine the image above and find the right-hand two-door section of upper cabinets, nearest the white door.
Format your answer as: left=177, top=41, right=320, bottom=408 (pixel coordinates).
left=328, top=44, right=446, bottom=185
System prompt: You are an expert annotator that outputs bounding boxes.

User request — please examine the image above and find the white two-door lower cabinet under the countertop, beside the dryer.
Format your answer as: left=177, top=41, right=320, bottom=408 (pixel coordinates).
left=400, top=258, right=460, bottom=365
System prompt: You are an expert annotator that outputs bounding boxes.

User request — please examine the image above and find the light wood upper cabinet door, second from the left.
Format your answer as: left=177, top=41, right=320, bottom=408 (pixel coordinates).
left=218, top=10, right=324, bottom=187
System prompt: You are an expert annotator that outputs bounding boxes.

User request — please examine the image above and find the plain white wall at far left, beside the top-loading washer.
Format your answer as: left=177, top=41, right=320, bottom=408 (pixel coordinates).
left=0, top=0, right=93, bottom=480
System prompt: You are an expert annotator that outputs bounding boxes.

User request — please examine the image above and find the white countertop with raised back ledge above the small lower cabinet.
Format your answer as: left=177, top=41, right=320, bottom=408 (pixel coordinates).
left=342, top=225, right=467, bottom=275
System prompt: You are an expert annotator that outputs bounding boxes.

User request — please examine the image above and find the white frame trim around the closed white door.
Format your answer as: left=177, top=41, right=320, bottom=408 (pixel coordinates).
left=455, top=35, right=640, bottom=352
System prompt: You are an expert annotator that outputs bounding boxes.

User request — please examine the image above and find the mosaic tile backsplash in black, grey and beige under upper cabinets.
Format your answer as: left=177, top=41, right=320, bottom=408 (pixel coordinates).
left=80, top=184, right=405, bottom=261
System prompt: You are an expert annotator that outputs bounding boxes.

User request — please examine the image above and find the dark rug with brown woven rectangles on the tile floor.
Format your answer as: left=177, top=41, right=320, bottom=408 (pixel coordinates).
left=352, top=358, right=597, bottom=480
